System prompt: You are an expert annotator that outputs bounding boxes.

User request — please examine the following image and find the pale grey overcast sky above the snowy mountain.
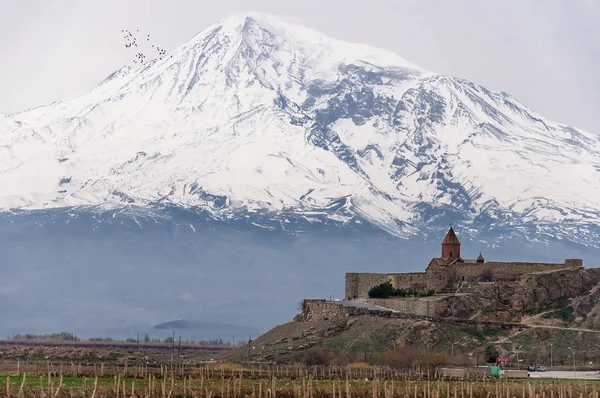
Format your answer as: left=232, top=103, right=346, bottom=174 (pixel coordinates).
left=0, top=0, right=600, bottom=133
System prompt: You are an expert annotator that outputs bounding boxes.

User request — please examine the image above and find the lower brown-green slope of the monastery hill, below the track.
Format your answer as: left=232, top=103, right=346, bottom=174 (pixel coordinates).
left=243, top=304, right=600, bottom=365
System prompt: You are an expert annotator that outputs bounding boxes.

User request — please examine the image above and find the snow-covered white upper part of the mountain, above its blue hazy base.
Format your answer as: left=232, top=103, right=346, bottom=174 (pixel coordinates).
left=0, top=14, right=600, bottom=243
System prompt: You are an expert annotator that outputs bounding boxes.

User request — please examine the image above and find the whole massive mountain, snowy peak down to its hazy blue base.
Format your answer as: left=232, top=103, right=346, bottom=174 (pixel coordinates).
left=0, top=14, right=600, bottom=339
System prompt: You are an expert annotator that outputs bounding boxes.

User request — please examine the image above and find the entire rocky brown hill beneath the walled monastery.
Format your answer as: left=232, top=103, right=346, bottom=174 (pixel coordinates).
left=243, top=269, right=600, bottom=363
